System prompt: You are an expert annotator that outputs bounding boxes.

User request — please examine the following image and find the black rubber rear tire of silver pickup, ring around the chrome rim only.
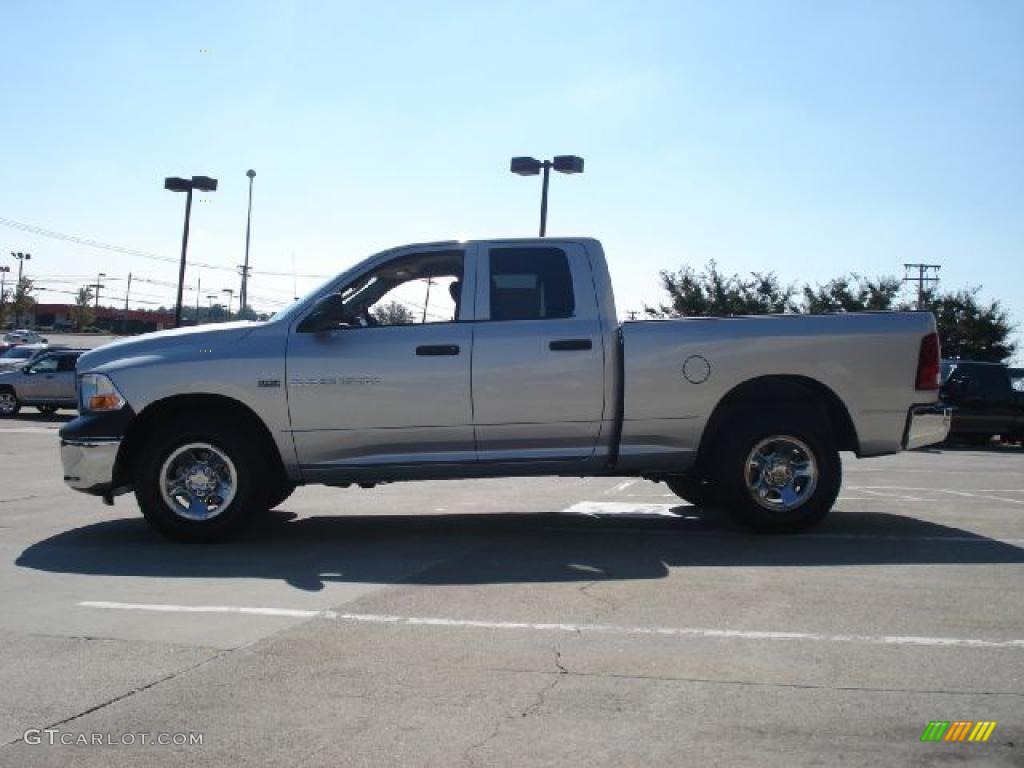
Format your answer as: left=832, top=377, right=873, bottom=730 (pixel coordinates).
left=715, top=410, right=843, bottom=534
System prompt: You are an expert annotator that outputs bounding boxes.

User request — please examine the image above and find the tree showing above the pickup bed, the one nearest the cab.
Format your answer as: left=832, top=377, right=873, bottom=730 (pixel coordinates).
left=644, top=261, right=798, bottom=317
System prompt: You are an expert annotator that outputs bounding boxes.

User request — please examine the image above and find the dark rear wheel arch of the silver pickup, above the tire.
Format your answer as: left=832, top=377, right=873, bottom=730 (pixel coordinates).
left=697, top=375, right=860, bottom=469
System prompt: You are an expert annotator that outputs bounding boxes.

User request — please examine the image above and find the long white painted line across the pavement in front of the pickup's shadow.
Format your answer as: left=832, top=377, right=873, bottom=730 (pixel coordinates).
left=78, top=601, right=1024, bottom=649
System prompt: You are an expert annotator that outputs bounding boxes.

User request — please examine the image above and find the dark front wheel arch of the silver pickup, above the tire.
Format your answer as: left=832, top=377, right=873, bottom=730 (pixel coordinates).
left=114, top=392, right=286, bottom=487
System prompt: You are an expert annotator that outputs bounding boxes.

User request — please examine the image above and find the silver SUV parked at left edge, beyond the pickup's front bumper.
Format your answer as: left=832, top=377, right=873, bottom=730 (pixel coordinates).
left=0, top=349, right=85, bottom=418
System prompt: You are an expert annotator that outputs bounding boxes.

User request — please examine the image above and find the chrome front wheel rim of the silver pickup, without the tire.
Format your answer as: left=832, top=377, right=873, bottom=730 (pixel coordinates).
left=160, top=442, right=239, bottom=520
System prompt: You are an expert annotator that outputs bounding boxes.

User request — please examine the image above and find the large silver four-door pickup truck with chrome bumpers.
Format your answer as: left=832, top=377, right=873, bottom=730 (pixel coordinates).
left=60, top=238, right=949, bottom=540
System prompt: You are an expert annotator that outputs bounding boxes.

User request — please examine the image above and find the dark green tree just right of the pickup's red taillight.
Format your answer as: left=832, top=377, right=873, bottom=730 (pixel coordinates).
left=921, top=288, right=1017, bottom=362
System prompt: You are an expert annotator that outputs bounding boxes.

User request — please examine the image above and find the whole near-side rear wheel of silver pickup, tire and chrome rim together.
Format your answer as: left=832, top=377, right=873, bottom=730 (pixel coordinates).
left=714, top=410, right=843, bottom=534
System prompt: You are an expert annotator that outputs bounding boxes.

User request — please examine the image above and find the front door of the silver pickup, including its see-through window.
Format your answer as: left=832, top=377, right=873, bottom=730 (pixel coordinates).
left=288, top=247, right=475, bottom=480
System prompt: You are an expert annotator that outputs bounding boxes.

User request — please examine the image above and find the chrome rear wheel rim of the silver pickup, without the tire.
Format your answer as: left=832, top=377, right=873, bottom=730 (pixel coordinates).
left=744, top=435, right=818, bottom=512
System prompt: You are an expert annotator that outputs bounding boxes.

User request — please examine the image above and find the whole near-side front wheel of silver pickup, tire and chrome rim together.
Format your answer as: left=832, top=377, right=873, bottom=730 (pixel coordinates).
left=135, top=415, right=268, bottom=542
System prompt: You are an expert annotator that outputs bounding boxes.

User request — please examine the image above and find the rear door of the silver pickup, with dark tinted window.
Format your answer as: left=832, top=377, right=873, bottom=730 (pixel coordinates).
left=473, top=244, right=605, bottom=462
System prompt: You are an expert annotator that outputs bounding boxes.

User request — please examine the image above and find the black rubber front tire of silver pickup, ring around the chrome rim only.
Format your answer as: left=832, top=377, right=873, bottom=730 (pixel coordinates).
left=135, top=419, right=266, bottom=542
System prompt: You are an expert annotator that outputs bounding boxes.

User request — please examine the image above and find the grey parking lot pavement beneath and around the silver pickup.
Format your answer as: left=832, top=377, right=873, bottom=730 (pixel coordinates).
left=0, top=413, right=1024, bottom=767
